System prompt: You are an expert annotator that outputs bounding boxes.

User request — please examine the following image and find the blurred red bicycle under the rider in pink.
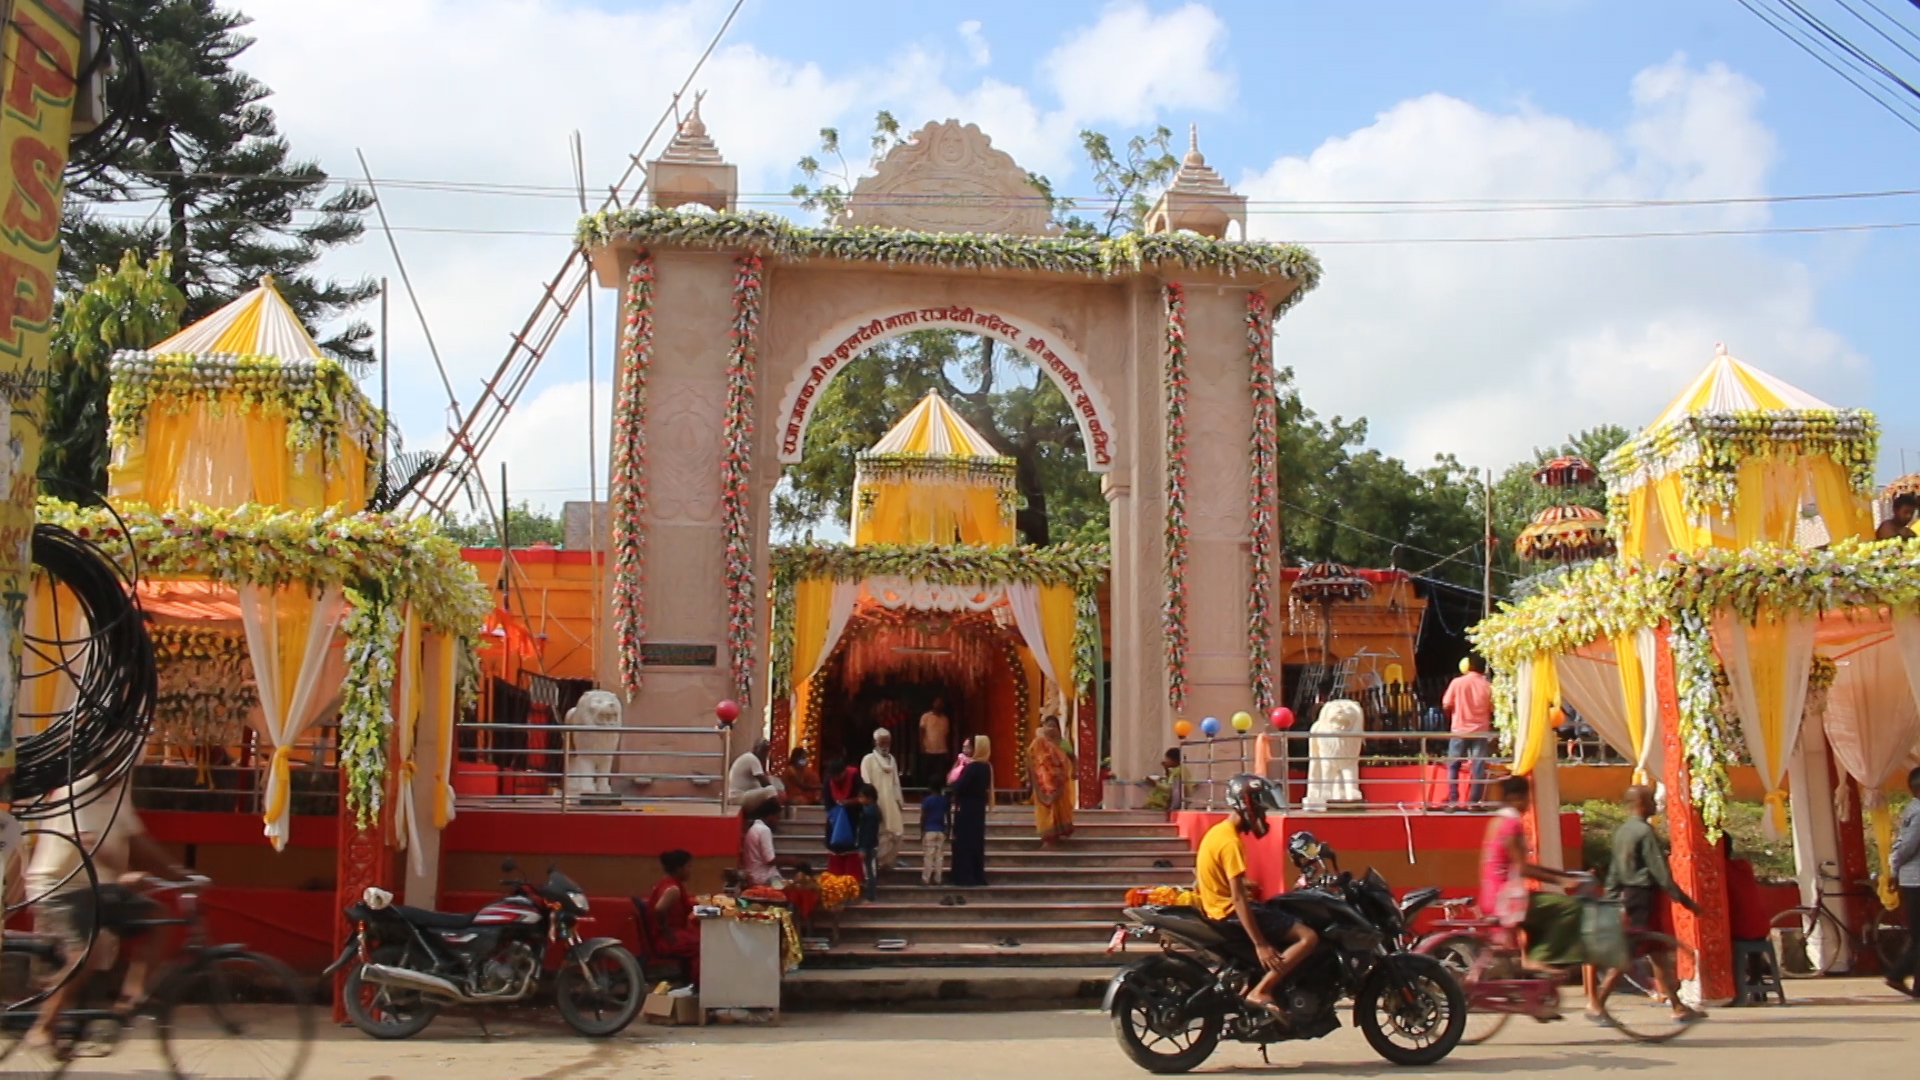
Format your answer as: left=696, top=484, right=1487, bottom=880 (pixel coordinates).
left=1417, top=887, right=1692, bottom=1045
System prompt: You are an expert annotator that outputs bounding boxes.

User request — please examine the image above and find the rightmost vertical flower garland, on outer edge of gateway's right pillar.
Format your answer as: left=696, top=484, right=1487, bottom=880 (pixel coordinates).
left=1246, top=290, right=1279, bottom=713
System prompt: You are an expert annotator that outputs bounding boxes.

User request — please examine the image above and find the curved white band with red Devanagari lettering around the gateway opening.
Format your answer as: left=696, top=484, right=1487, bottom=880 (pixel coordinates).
left=774, top=304, right=1117, bottom=473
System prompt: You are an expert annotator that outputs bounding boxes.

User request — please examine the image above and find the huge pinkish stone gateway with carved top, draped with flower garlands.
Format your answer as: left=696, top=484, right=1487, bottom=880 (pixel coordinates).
left=582, top=121, right=1319, bottom=790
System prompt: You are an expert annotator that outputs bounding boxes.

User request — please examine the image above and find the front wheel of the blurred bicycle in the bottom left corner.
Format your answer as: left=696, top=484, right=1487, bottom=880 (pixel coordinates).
left=154, top=951, right=313, bottom=1080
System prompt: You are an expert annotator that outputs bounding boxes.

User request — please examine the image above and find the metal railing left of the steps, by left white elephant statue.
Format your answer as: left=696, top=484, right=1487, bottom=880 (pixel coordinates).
left=453, top=723, right=732, bottom=811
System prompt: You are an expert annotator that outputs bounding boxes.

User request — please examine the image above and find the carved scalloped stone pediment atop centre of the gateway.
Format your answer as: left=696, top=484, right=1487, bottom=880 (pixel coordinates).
left=835, top=119, right=1060, bottom=236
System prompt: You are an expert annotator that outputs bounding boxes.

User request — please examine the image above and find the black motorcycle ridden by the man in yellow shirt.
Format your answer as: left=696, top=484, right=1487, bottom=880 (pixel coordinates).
left=1102, top=834, right=1467, bottom=1072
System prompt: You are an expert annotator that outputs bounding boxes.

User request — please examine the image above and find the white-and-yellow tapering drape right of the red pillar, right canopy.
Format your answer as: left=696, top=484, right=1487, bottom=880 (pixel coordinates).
left=1713, top=609, right=1818, bottom=840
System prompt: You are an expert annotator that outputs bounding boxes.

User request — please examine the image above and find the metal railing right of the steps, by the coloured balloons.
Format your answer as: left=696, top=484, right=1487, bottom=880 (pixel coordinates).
left=1152, top=730, right=1509, bottom=809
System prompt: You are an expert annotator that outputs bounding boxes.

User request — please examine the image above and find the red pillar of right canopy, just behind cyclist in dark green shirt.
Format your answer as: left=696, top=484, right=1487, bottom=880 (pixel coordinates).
left=1653, top=626, right=1734, bottom=1005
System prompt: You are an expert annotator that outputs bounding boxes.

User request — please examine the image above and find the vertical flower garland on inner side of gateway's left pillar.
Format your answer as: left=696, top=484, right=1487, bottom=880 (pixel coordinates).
left=720, top=254, right=760, bottom=703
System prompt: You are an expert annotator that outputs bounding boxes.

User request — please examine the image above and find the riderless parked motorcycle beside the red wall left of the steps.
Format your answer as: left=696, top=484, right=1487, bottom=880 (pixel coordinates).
left=326, top=859, right=647, bottom=1040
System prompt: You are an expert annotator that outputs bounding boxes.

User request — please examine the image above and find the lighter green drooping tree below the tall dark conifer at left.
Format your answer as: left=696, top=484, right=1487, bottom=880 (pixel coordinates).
left=40, top=252, right=186, bottom=503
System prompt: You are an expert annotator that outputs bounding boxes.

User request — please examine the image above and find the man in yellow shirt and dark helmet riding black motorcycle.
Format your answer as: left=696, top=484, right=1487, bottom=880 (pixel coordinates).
left=1194, top=773, right=1319, bottom=1020
